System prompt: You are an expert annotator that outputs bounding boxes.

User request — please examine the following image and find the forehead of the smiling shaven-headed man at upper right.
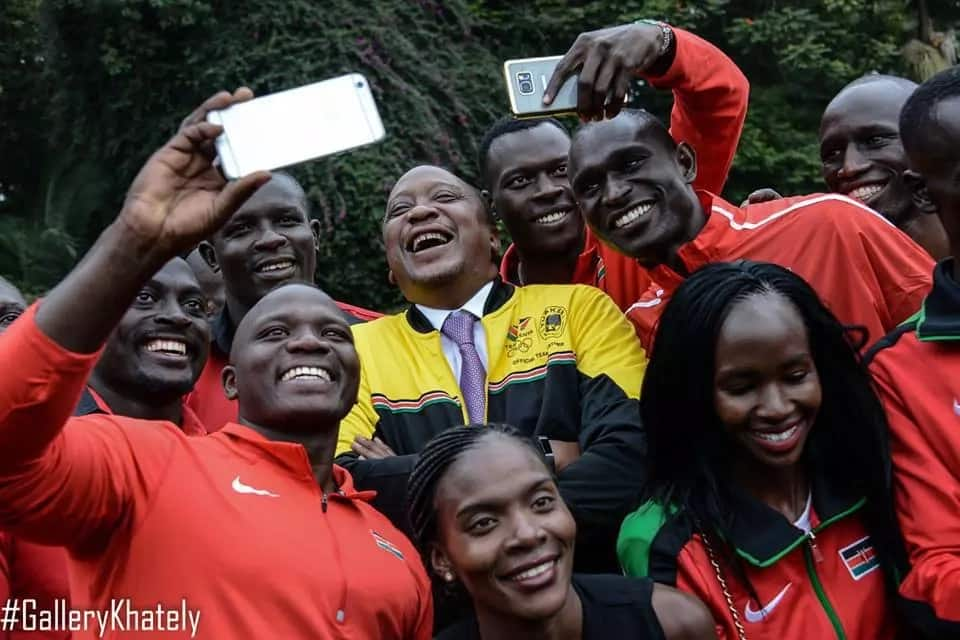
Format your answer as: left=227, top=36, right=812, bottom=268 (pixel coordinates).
left=820, top=80, right=912, bottom=137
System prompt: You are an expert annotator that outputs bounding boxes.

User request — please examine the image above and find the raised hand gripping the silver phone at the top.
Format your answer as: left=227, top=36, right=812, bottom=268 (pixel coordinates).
left=543, top=23, right=667, bottom=121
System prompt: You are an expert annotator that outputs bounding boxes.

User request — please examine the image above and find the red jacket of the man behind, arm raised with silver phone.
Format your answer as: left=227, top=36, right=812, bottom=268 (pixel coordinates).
left=500, top=29, right=750, bottom=311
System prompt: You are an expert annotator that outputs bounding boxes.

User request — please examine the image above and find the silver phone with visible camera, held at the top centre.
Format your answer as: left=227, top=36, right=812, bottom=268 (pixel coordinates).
left=503, top=56, right=577, bottom=117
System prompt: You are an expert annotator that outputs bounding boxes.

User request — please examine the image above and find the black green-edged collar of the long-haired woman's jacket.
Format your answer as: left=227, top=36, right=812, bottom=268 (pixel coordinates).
left=727, top=474, right=864, bottom=567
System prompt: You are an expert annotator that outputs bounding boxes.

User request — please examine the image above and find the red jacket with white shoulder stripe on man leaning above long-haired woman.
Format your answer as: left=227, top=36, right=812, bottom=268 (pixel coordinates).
left=627, top=191, right=933, bottom=353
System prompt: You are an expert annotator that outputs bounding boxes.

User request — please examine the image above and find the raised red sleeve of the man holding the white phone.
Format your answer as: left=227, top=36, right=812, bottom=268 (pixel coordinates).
left=0, top=307, right=176, bottom=551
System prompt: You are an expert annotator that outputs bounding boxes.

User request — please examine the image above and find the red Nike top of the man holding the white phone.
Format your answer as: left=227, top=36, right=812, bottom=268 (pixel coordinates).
left=0, top=306, right=433, bottom=640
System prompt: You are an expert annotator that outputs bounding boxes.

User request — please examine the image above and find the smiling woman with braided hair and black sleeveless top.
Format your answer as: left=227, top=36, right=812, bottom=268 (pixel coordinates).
left=408, top=424, right=714, bottom=640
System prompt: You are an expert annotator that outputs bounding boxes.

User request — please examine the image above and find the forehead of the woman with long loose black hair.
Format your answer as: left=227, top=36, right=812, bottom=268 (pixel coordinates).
left=717, top=292, right=809, bottom=358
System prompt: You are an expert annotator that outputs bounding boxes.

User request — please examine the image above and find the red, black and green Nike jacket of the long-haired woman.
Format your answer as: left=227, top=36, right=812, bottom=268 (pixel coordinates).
left=617, top=482, right=896, bottom=640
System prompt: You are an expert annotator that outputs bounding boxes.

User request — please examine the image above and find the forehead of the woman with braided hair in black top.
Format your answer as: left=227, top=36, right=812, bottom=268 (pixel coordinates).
left=437, top=435, right=550, bottom=505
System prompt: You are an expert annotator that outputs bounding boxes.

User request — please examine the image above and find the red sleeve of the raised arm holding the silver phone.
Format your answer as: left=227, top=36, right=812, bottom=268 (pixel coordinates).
left=646, top=28, right=750, bottom=193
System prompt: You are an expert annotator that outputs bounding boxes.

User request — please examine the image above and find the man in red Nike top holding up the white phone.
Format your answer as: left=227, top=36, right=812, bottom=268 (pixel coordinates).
left=0, top=90, right=432, bottom=640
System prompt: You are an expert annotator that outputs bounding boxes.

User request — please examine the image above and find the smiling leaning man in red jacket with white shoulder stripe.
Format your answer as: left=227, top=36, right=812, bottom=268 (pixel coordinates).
left=570, top=111, right=933, bottom=348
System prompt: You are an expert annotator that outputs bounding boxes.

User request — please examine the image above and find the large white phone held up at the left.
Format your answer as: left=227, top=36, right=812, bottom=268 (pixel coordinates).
left=207, top=73, right=385, bottom=178
